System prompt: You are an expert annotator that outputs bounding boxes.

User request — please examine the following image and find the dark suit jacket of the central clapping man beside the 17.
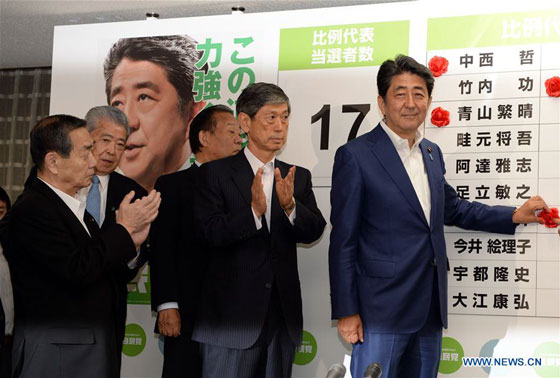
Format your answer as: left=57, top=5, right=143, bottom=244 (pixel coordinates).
left=193, top=151, right=325, bottom=349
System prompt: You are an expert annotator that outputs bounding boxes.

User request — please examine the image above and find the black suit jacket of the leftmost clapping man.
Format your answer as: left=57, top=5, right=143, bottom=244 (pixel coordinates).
left=0, top=179, right=136, bottom=378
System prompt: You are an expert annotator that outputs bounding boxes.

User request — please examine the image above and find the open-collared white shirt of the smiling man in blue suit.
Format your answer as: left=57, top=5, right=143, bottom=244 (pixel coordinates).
left=379, top=121, right=432, bottom=225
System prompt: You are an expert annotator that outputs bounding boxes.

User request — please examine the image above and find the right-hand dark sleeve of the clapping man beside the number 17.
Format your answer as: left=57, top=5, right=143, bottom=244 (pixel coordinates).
left=284, top=167, right=326, bottom=244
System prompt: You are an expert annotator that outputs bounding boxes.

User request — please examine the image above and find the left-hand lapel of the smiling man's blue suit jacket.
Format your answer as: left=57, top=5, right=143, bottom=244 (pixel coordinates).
left=368, top=125, right=427, bottom=225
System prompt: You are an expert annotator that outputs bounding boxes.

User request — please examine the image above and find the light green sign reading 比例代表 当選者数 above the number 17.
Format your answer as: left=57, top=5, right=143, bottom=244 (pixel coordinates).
left=278, top=21, right=409, bottom=71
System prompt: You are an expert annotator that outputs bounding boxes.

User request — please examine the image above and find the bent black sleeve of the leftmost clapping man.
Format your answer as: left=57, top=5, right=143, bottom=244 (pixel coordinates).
left=10, top=202, right=136, bottom=285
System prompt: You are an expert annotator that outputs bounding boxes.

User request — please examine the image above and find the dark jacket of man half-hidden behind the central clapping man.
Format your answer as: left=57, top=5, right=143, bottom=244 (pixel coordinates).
left=150, top=165, right=206, bottom=335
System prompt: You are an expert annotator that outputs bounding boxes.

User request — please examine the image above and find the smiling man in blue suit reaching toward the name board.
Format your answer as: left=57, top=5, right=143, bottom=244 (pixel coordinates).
left=329, top=56, right=547, bottom=378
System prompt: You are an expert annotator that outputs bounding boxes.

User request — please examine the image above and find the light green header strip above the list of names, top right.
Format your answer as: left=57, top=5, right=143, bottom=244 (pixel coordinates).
left=428, top=9, right=560, bottom=50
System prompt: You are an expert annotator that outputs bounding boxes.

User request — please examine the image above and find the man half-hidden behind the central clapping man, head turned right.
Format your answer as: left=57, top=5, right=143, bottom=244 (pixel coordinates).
left=150, top=105, right=241, bottom=378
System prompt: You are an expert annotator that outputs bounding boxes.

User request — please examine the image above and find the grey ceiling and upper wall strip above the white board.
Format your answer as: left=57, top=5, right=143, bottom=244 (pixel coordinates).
left=0, top=0, right=402, bottom=68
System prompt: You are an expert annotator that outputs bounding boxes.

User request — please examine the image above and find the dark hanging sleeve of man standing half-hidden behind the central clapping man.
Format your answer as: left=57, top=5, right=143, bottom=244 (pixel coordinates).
left=150, top=177, right=182, bottom=311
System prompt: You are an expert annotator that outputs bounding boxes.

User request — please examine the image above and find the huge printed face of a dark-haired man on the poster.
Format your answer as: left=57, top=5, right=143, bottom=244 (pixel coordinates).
left=104, top=35, right=205, bottom=188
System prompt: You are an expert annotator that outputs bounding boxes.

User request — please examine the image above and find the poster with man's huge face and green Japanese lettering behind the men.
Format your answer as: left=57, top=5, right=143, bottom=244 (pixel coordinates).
left=55, top=30, right=260, bottom=189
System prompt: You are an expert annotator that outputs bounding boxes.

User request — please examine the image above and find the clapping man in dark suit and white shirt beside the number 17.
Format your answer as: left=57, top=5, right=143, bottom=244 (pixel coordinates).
left=193, top=83, right=325, bottom=378
